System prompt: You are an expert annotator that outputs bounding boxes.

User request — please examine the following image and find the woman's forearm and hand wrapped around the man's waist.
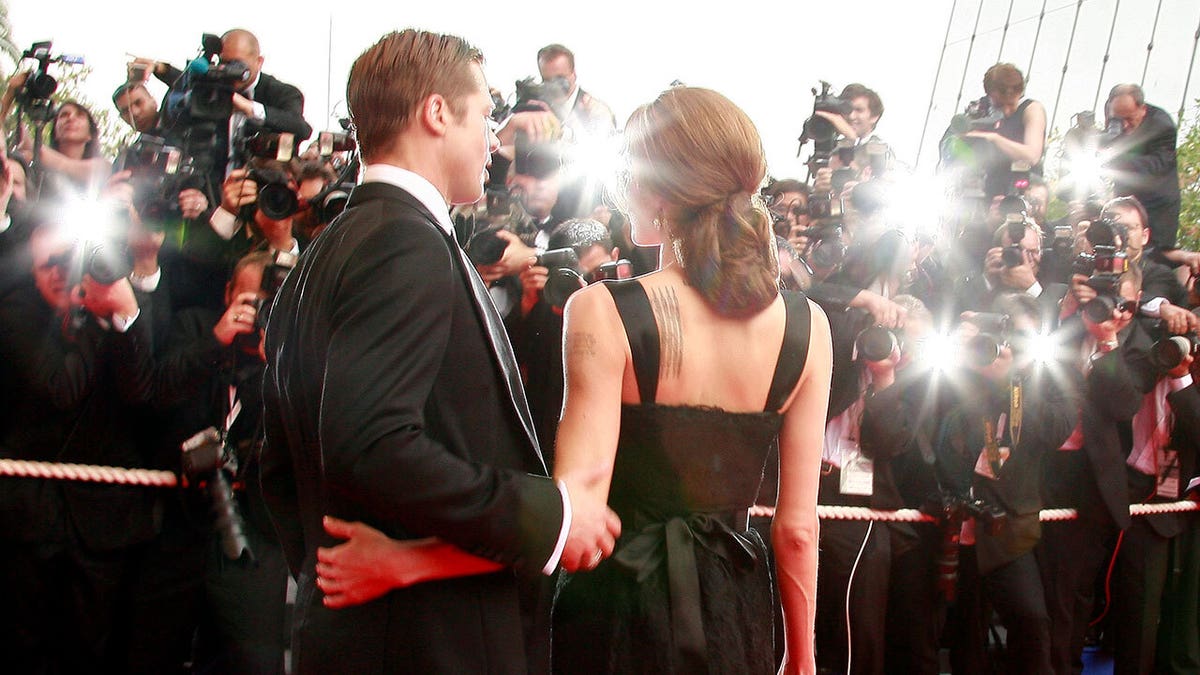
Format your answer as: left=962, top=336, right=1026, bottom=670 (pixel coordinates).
left=317, top=515, right=502, bottom=609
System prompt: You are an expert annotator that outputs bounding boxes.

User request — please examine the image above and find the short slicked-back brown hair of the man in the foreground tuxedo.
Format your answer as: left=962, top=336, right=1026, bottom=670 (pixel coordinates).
left=346, top=29, right=484, bottom=161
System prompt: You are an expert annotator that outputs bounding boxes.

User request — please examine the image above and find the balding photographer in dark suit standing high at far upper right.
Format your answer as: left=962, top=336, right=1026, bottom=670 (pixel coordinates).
left=1104, top=84, right=1184, bottom=254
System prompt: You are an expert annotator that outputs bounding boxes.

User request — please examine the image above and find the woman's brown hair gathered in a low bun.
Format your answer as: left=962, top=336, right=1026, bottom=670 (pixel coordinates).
left=625, top=86, right=779, bottom=317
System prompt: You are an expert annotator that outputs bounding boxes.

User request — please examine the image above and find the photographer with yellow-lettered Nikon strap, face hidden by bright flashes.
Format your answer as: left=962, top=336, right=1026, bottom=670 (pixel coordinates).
left=935, top=293, right=1078, bottom=674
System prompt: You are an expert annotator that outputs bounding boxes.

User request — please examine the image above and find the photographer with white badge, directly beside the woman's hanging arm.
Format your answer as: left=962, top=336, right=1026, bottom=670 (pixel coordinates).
left=816, top=297, right=931, bottom=674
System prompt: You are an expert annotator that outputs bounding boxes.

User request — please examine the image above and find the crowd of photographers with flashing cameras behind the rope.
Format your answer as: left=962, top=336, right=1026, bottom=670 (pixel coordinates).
left=0, top=29, right=1200, bottom=675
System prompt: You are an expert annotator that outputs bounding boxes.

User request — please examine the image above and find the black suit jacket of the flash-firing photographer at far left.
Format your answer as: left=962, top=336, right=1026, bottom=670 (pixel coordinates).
left=0, top=279, right=156, bottom=551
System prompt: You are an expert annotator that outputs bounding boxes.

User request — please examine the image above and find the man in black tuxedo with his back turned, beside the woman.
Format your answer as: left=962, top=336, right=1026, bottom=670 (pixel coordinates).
left=262, top=30, right=619, bottom=673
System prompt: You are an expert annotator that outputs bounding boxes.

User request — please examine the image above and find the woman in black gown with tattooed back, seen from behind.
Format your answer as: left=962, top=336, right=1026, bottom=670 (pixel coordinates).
left=318, top=88, right=832, bottom=674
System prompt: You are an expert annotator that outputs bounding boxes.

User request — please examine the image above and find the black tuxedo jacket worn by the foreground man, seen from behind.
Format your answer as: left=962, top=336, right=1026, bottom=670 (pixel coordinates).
left=262, top=183, right=563, bottom=673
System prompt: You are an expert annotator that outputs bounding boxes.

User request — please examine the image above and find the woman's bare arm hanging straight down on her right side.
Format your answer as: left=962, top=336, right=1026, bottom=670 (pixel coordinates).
left=772, top=301, right=833, bottom=674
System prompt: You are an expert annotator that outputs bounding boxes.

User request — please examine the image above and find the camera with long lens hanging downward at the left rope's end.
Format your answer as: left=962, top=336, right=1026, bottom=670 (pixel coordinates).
left=180, top=426, right=254, bottom=561
